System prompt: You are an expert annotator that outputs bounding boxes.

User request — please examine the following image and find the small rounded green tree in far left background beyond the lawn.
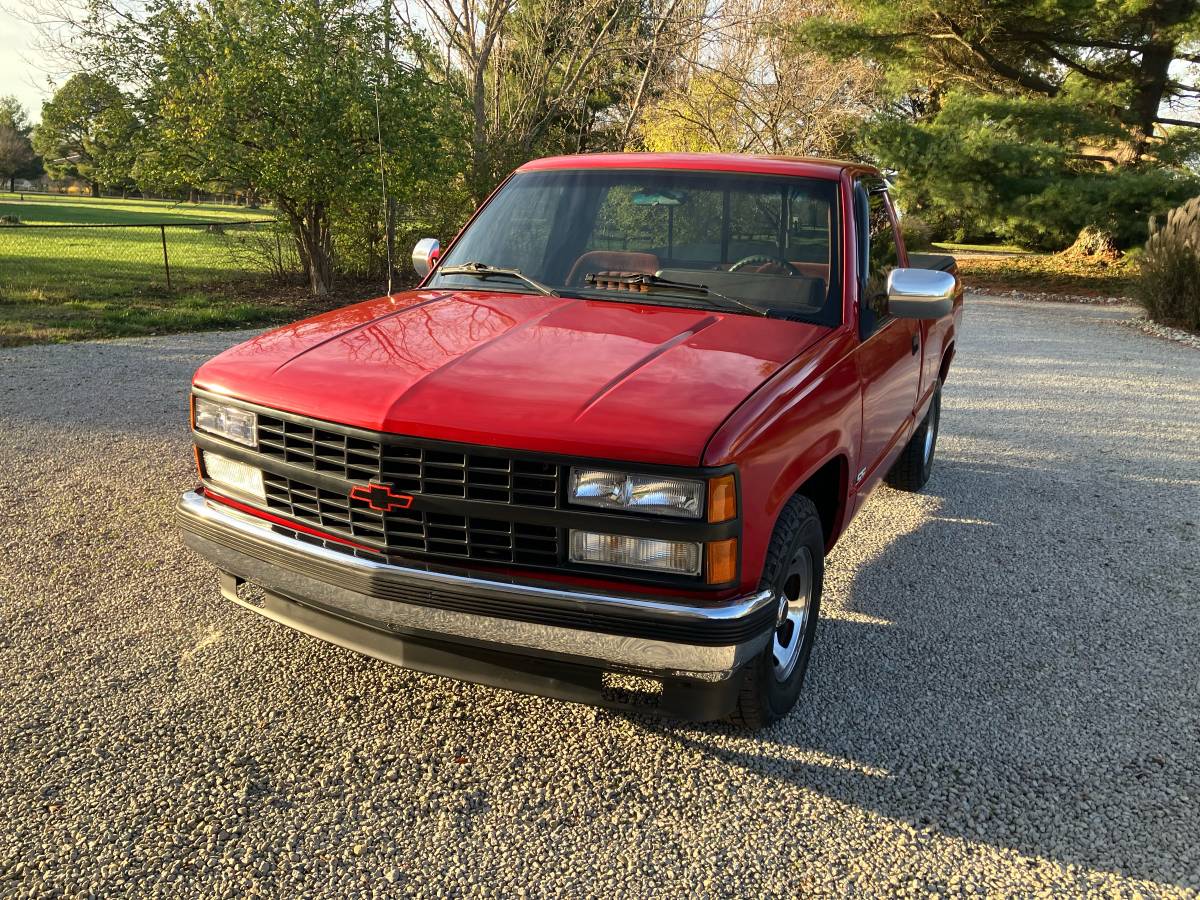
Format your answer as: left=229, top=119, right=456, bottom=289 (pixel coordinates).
left=34, top=73, right=139, bottom=197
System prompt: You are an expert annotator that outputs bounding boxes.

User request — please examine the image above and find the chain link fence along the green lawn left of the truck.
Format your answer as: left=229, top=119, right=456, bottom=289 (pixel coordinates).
left=0, top=218, right=300, bottom=301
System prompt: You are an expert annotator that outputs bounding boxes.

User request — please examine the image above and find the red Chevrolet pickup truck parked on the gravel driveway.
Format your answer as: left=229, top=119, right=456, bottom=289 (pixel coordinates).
left=178, top=154, right=962, bottom=727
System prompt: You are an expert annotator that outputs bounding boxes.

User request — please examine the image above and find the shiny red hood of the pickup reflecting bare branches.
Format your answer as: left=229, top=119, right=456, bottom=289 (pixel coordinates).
left=196, top=290, right=828, bottom=464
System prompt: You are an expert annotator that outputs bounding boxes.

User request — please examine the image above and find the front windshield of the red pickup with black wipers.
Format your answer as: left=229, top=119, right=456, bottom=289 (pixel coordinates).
left=430, top=169, right=841, bottom=325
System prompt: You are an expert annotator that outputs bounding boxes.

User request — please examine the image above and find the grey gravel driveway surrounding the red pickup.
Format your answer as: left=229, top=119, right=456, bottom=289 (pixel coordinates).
left=0, top=298, right=1200, bottom=898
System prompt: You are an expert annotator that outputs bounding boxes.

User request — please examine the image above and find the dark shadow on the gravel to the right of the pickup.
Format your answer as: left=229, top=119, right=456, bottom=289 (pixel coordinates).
left=636, top=458, right=1200, bottom=887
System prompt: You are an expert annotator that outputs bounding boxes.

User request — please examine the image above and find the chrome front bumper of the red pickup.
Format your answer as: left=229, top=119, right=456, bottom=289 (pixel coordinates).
left=176, top=492, right=775, bottom=682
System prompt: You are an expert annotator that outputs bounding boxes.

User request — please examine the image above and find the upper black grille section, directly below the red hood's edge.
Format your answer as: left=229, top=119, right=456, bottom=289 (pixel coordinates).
left=258, top=414, right=558, bottom=508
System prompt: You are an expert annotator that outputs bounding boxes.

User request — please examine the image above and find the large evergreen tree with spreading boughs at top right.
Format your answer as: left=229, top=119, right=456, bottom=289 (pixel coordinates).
left=796, top=0, right=1200, bottom=248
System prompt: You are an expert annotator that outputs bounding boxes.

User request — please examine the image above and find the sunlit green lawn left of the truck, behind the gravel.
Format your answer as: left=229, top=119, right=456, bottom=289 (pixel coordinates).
left=0, top=193, right=347, bottom=346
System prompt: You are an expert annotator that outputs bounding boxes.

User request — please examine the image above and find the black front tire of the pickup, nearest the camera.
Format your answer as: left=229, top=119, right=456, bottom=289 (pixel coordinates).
left=730, top=496, right=824, bottom=728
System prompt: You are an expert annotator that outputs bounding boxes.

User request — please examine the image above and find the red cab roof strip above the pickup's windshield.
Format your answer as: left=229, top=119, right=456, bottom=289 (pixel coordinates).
left=517, top=154, right=877, bottom=181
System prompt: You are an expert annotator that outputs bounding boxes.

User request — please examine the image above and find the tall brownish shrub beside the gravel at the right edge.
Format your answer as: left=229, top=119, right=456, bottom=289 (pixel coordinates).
left=1136, top=197, right=1200, bottom=331
